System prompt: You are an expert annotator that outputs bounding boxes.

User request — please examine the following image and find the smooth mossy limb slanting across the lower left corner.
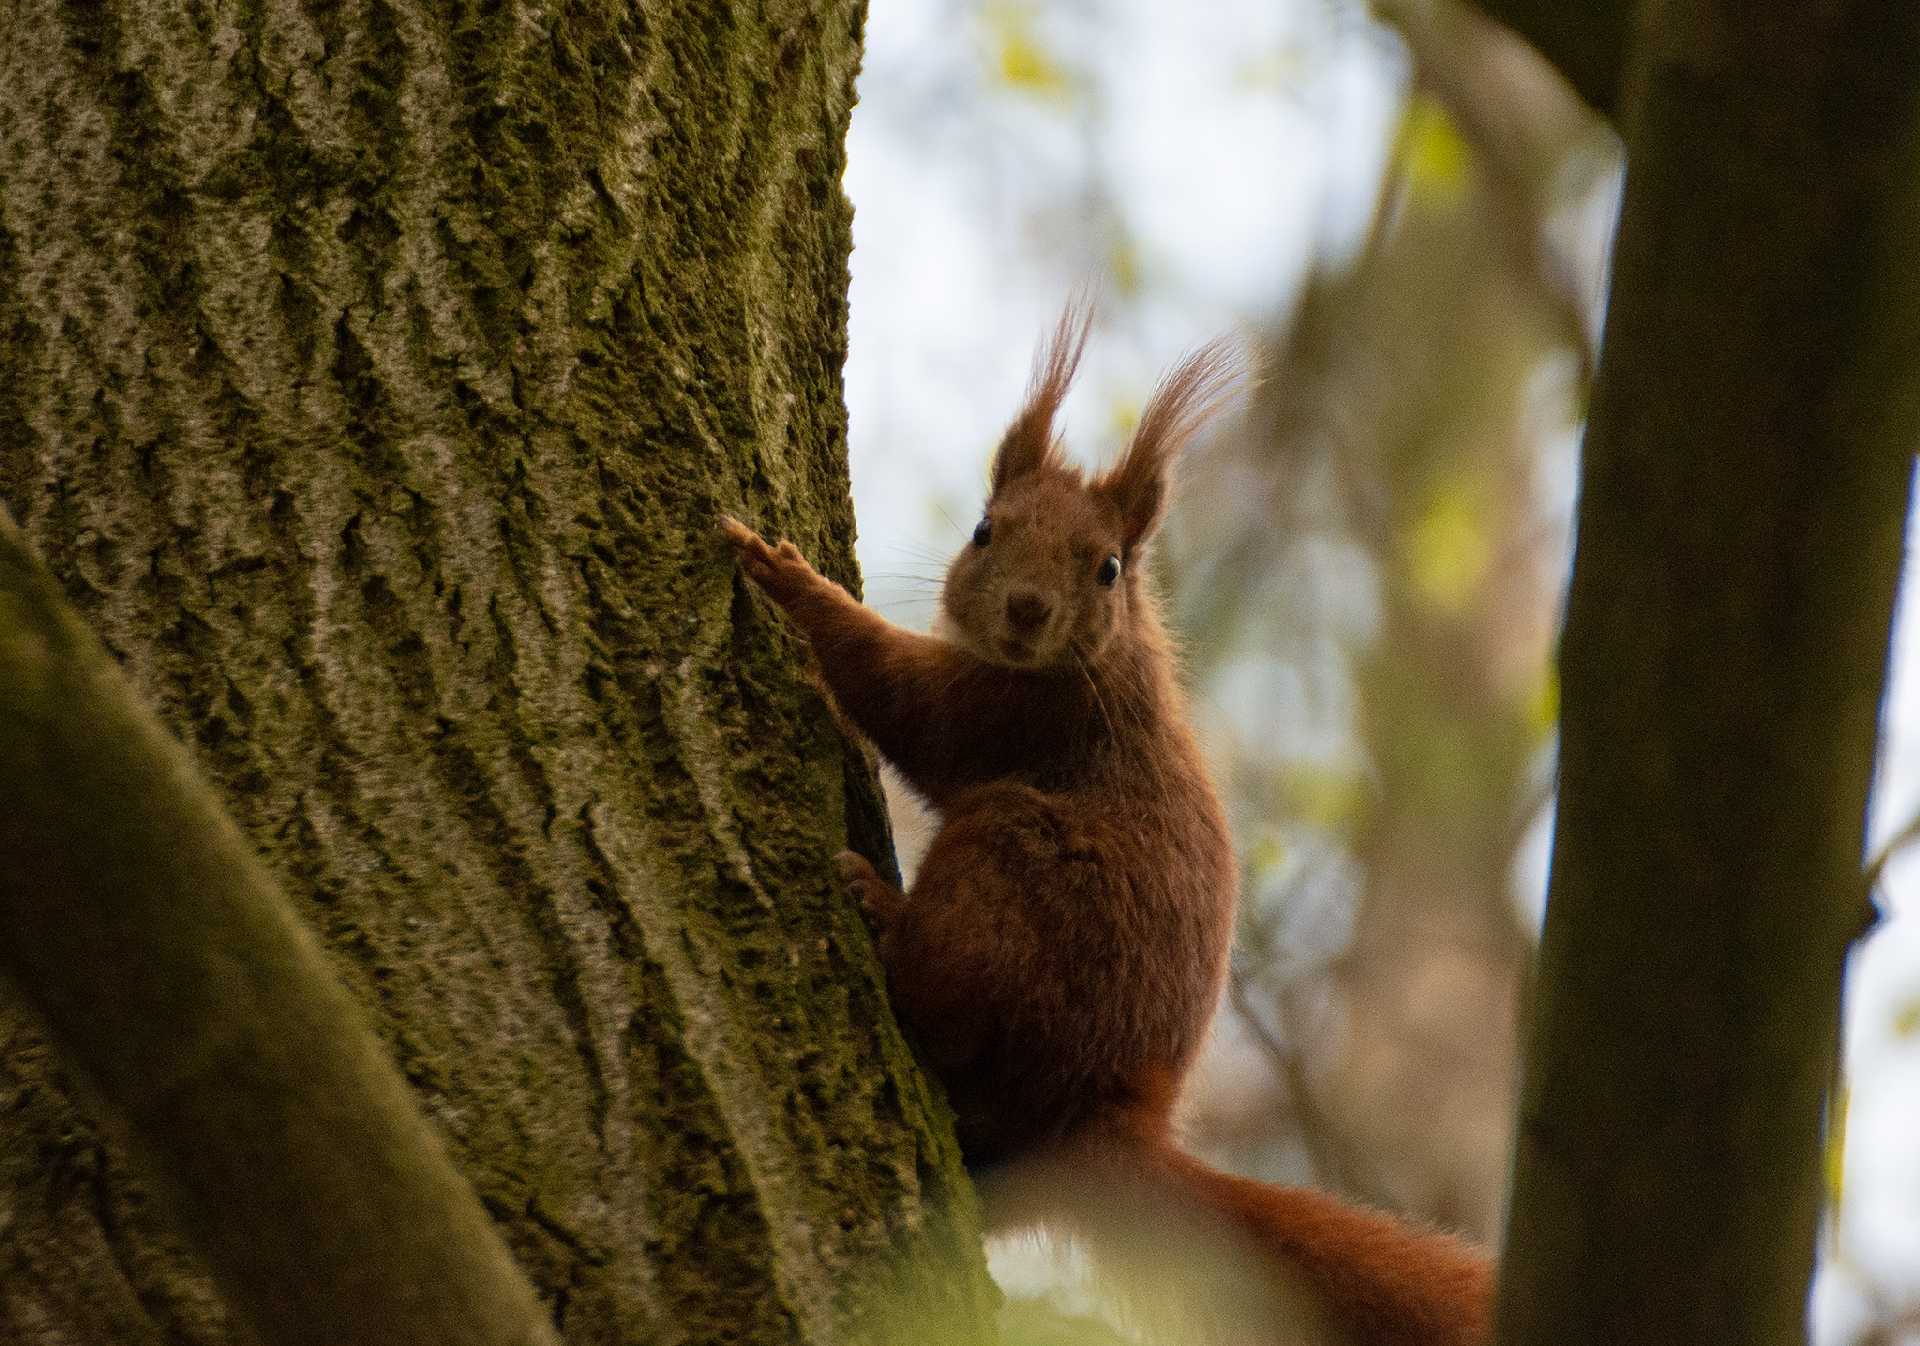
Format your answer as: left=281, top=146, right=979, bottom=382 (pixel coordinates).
left=0, top=511, right=559, bottom=1346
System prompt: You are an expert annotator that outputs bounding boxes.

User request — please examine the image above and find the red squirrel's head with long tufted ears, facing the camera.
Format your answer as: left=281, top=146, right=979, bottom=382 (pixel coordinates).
left=941, top=305, right=1236, bottom=668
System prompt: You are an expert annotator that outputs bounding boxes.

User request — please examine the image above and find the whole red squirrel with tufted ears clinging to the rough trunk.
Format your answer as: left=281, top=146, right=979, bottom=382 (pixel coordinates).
left=722, top=305, right=1494, bottom=1346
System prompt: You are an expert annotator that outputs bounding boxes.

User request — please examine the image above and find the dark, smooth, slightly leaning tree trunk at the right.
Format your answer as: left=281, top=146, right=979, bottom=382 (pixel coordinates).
left=1501, top=0, right=1920, bottom=1346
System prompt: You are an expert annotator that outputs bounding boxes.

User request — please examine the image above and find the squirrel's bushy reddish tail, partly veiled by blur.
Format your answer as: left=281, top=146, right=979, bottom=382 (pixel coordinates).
left=983, top=1129, right=1494, bottom=1346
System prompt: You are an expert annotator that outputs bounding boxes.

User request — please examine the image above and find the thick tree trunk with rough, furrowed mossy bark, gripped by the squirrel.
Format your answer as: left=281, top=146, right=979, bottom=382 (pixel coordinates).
left=0, top=0, right=993, bottom=1344
